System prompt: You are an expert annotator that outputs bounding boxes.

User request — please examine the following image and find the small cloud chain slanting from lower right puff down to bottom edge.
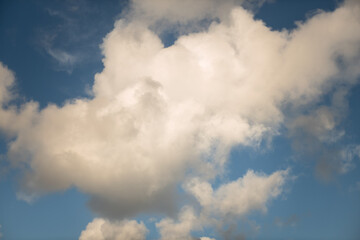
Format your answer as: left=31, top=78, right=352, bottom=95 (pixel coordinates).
left=156, top=170, right=289, bottom=240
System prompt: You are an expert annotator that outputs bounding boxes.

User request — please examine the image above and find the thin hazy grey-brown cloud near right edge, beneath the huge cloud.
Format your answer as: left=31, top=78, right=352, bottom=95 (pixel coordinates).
left=287, top=88, right=358, bottom=181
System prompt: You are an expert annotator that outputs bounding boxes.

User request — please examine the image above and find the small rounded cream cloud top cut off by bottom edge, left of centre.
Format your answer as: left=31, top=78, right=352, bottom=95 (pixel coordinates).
left=79, top=218, right=148, bottom=240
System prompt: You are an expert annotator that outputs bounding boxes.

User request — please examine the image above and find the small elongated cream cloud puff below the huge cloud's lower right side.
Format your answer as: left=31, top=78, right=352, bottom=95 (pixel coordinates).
left=185, top=170, right=288, bottom=218
